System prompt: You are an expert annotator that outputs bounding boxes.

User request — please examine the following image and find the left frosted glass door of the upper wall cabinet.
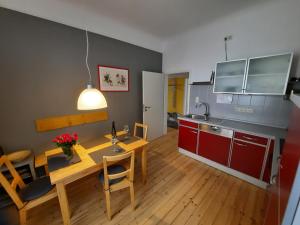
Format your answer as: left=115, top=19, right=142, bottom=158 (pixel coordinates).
left=214, top=59, right=247, bottom=93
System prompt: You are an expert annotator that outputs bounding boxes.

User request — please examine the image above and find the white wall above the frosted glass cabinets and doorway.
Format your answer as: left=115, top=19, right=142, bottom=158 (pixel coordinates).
left=163, top=0, right=300, bottom=81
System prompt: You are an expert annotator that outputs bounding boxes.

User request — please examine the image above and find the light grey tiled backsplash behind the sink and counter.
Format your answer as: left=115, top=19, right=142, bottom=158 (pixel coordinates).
left=189, top=85, right=292, bottom=128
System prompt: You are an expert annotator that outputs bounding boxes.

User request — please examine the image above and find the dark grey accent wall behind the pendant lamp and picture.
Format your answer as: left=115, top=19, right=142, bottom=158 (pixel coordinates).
left=0, top=8, right=162, bottom=152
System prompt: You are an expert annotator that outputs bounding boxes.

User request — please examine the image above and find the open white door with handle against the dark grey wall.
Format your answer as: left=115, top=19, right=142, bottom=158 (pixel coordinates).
left=143, top=71, right=164, bottom=140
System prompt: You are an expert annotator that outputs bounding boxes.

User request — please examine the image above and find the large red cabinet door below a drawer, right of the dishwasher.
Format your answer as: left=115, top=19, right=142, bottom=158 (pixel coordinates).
left=230, top=140, right=266, bottom=178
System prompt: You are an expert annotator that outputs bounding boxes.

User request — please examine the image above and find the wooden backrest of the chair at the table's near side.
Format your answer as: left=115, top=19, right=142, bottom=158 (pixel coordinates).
left=103, top=151, right=134, bottom=190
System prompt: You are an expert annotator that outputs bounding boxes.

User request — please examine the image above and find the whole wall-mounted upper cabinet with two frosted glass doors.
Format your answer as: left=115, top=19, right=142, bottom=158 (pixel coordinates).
left=214, top=53, right=293, bottom=95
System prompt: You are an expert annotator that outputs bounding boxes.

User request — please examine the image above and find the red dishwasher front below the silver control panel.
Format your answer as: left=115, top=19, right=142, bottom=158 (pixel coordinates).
left=198, top=131, right=231, bottom=166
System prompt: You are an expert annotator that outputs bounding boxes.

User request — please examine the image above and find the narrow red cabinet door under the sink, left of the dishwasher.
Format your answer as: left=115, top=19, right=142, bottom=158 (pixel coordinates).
left=178, top=126, right=198, bottom=154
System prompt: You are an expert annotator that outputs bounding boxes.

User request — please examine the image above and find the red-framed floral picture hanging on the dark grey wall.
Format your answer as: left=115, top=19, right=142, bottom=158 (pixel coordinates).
left=98, top=65, right=129, bottom=91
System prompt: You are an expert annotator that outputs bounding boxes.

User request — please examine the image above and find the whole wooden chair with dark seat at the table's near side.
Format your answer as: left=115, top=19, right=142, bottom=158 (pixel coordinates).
left=99, top=152, right=135, bottom=220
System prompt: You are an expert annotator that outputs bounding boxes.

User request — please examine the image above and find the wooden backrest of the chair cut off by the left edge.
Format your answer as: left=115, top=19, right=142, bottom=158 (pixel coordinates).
left=0, top=155, right=25, bottom=209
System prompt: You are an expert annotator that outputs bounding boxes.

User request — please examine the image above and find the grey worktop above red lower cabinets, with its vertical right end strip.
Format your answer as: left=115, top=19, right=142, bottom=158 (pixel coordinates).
left=178, top=116, right=287, bottom=184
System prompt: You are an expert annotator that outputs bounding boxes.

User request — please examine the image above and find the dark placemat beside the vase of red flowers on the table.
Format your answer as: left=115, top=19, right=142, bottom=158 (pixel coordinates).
left=47, top=151, right=81, bottom=172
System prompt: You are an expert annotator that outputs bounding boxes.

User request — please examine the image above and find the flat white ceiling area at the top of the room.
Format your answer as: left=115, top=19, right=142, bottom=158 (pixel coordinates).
left=59, top=0, right=263, bottom=38
